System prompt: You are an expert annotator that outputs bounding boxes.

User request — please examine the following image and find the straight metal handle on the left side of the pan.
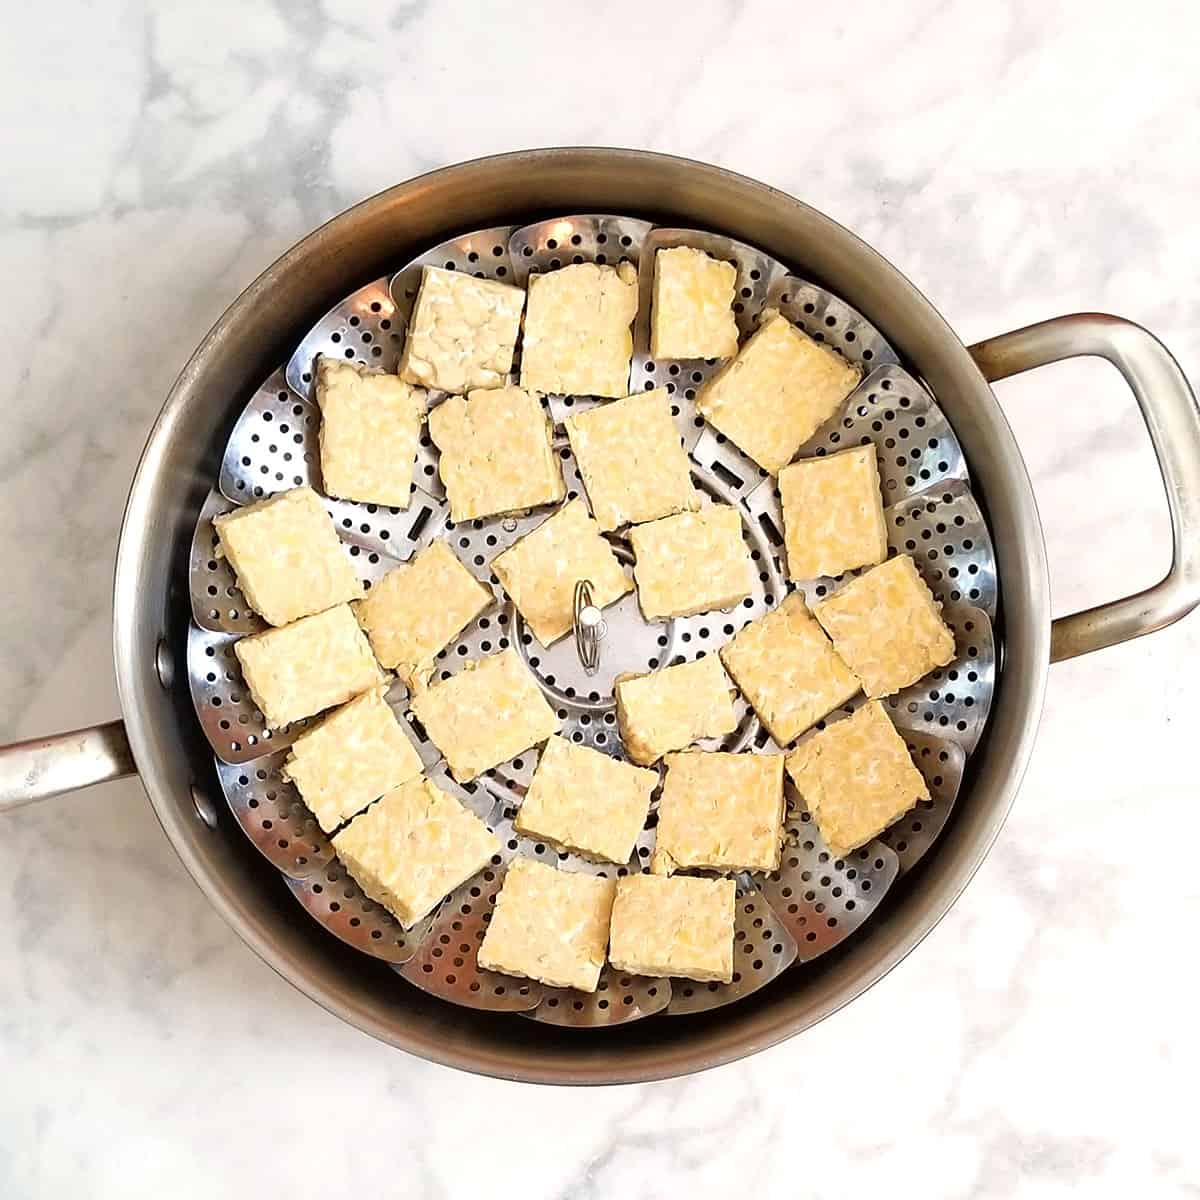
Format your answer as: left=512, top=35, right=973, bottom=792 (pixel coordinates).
left=0, top=721, right=137, bottom=812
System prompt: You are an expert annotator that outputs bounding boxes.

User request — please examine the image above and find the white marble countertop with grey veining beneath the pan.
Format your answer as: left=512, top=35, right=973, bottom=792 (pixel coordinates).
left=0, top=0, right=1200, bottom=1200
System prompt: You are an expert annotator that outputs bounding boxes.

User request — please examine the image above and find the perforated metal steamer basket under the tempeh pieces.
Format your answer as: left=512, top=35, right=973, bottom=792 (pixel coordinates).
left=175, top=216, right=997, bottom=1025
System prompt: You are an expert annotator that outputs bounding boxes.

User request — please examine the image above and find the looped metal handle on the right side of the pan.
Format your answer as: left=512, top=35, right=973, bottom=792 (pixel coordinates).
left=970, top=312, right=1200, bottom=662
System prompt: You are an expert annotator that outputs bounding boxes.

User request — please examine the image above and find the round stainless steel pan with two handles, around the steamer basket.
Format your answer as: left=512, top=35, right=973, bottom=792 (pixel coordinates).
left=0, top=150, right=1200, bottom=1084
